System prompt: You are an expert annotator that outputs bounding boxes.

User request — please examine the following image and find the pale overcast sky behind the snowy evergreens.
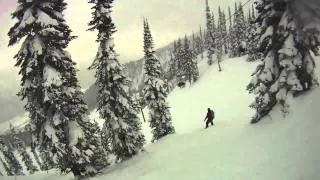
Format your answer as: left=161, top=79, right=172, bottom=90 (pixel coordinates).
left=0, top=0, right=245, bottom=121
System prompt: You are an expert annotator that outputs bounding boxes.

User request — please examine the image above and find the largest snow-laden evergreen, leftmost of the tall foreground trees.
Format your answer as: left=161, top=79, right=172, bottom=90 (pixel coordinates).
left=8, top=0, right=94, bottom=176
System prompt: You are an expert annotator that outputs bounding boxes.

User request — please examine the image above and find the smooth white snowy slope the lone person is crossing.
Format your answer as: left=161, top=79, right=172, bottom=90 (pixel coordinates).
left=5, top=55, right=320, bottom=180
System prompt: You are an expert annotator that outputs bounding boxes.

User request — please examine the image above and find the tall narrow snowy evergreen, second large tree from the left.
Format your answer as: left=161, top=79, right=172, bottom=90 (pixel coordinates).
left=89, top=0, right=145, bottom=162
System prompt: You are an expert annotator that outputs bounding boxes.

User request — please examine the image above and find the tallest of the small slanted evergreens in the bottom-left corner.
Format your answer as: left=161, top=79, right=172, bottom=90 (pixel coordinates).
left=11, top=128, right=38, bottom=174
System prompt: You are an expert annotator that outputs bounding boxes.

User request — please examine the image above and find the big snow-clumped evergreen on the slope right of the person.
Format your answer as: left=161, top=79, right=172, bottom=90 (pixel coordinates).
left=247, top=0, right=318, bottom=123
